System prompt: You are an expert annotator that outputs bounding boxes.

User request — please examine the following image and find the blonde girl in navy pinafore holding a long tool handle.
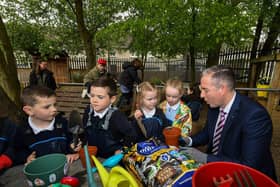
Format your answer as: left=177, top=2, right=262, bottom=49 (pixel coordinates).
left=132, top=82, right=168, bottom=141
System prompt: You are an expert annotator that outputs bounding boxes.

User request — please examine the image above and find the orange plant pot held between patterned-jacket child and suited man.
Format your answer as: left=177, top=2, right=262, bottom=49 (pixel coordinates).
left=163, top=127, right=181, bottom=147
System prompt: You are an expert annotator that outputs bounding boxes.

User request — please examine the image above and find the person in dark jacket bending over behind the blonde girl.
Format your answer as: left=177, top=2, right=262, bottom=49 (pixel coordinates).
left=117, top=59, right=143, bottom=107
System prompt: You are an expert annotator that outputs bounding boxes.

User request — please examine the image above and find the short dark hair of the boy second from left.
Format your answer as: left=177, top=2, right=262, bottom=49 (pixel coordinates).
left=90, top=75, right=118, bottom=97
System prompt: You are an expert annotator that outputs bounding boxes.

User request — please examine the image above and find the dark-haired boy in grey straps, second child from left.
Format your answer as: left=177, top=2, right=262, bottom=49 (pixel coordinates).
left=83, top=76, right=136, bottom=158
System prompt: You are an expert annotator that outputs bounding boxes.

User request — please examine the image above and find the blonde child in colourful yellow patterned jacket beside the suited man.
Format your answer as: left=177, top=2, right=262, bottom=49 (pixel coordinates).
left=159, top=79, right=192, bottom=137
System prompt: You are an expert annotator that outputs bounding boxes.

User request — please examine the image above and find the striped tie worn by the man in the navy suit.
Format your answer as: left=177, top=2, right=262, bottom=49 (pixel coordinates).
left=212, top=109, right=226, bottom=155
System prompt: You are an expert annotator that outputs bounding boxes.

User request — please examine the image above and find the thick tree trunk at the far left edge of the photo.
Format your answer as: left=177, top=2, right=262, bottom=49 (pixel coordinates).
left=0, top=16, right=20, bottom=113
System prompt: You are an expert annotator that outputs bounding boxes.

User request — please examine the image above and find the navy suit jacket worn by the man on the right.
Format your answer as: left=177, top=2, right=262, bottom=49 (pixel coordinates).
left=191, top=93, right=276, bottom=181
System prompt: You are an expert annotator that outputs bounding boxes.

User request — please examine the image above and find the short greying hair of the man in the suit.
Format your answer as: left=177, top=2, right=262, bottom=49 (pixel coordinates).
left=202, top=65, right=235, bottom=90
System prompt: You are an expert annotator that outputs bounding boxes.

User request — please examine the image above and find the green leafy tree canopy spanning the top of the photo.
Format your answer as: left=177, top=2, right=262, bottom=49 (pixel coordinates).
left=0, top=0, right=277, bottom=63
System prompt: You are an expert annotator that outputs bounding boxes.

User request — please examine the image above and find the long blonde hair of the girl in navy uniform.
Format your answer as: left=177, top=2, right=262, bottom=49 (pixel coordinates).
left=132, top=81, right=159, bottom=112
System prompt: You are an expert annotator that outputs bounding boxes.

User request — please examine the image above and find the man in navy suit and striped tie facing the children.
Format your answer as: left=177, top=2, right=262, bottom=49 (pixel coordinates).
left=185, top=65, right=277, bottom=181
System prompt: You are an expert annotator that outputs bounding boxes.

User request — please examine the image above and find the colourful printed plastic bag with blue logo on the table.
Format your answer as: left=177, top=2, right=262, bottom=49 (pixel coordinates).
left=123, top=139, right=200, bottom=187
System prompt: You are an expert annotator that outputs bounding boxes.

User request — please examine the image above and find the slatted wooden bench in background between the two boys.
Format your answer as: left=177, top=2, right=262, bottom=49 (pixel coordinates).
left=56, top=84, right=89, bottom=118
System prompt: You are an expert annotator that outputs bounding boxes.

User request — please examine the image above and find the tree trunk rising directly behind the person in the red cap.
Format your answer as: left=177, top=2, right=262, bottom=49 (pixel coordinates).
left=73, top=0, right=96, bottom=69
